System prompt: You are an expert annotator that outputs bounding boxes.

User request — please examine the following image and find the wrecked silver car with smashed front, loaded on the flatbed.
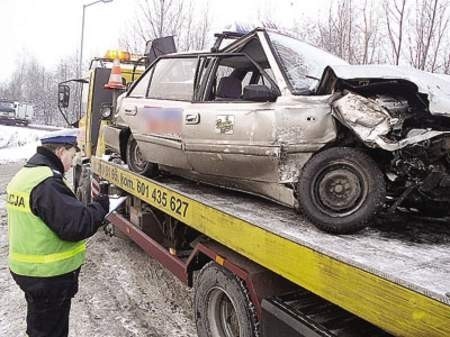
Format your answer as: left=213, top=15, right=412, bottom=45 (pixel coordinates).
left=104, top=29, right=450, bottom=233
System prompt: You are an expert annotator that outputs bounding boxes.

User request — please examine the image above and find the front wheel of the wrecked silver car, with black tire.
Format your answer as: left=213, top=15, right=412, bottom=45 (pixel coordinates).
left=297, top=147, right=386, bottom=234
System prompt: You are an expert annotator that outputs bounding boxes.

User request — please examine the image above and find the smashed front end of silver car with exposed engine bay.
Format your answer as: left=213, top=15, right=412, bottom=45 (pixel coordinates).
left=328, top=67, right=450, bottom=216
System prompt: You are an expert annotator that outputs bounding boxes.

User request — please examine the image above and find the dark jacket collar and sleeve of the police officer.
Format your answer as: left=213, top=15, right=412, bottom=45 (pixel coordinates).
left=25, top=147, right=107, bottom=241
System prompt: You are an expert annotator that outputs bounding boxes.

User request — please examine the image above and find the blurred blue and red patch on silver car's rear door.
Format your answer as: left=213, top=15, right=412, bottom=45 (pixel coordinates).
left=143, top=106, right=183, bottom=137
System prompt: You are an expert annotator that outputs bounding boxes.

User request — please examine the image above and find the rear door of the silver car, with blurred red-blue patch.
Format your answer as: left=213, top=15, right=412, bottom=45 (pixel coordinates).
left=121, top=56, right=198, bottom=169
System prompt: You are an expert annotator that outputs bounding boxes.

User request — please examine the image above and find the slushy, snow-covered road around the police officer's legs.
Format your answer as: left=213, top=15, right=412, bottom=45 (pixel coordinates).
left=0, top=162, right=197, bottom=337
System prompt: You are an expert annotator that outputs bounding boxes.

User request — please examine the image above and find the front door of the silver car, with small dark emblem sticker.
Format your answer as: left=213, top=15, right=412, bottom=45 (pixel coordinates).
left=183, top=55, right=279, bottom=184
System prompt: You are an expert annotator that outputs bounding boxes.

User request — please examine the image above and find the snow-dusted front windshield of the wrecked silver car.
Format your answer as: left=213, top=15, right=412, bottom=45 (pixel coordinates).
left=268, top=32, right=348, bottom=94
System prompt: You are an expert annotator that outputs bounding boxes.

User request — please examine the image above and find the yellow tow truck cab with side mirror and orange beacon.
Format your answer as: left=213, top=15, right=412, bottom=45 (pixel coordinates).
left=58, top=50, right=144, bottom=202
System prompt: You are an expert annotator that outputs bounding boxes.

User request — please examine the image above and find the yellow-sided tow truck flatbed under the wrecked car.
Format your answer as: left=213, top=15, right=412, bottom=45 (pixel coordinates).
left=91, top=157, right=450, bottom=337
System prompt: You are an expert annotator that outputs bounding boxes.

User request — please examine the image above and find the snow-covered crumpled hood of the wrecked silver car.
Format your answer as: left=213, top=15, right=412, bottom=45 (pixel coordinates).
left=325, top=64, right=450, bottom=116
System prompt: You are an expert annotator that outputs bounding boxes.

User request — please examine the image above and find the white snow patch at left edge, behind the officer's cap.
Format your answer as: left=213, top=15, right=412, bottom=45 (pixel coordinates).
left=0, top=125, right=55, bottom=165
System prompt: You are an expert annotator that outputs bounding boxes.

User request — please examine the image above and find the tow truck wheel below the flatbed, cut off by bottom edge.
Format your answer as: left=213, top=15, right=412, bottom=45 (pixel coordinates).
left=194, top=262, right=259, bottom=337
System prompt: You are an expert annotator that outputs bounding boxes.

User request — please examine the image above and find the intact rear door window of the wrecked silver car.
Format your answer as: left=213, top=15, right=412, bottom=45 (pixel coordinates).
left=147, top=57, right=198, bottom=101
